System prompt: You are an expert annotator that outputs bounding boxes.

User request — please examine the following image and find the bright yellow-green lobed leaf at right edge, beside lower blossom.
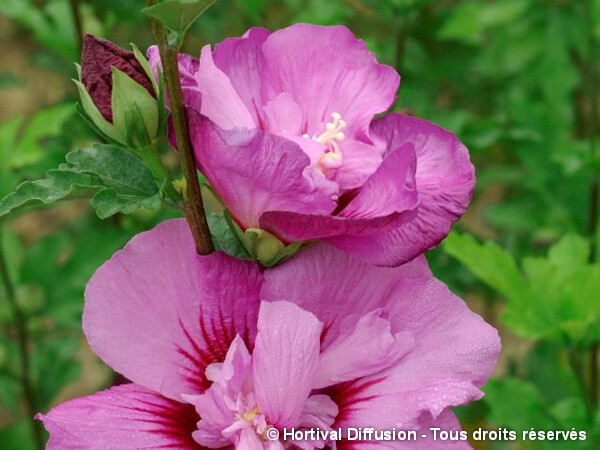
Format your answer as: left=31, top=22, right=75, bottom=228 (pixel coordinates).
left=444, top=233, right=600, bottom=346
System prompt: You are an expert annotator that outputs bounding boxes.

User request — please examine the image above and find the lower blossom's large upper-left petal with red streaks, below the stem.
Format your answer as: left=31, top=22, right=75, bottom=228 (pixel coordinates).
left=83, top=220, right=262, bottom=400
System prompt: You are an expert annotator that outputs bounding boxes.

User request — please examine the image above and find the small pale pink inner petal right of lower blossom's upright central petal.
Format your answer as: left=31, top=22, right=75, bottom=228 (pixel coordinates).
left=313, top=310, right=415, bottom=389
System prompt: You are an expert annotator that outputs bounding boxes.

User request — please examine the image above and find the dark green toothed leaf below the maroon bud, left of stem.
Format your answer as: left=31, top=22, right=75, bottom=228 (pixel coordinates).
left=0, top=145, right=161, bottom=218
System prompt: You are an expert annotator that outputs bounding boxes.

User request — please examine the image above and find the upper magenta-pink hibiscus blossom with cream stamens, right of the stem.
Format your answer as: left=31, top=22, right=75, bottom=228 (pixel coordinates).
left=148, top=24, right=475, bottom=266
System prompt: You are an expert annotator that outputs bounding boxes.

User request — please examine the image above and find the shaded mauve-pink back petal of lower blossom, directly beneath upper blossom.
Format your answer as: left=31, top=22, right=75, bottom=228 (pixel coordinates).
left=260, top=244, right=432, bottom=344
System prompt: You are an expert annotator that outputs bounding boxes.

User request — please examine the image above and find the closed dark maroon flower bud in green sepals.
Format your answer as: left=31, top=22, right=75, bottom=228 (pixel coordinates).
left=75, top=35, right=160, bottom=149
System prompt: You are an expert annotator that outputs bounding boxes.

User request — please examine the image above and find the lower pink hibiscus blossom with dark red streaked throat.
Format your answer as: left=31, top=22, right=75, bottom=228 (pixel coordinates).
left=40, top=220, right=500, bottom=450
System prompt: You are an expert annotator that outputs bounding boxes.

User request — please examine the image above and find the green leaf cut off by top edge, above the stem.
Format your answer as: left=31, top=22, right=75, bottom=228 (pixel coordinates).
left=142, top=0, right=216, bottom=33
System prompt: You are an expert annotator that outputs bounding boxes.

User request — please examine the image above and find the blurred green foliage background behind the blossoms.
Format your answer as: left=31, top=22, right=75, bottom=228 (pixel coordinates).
left=0, top=0, right=600, bottom=450
